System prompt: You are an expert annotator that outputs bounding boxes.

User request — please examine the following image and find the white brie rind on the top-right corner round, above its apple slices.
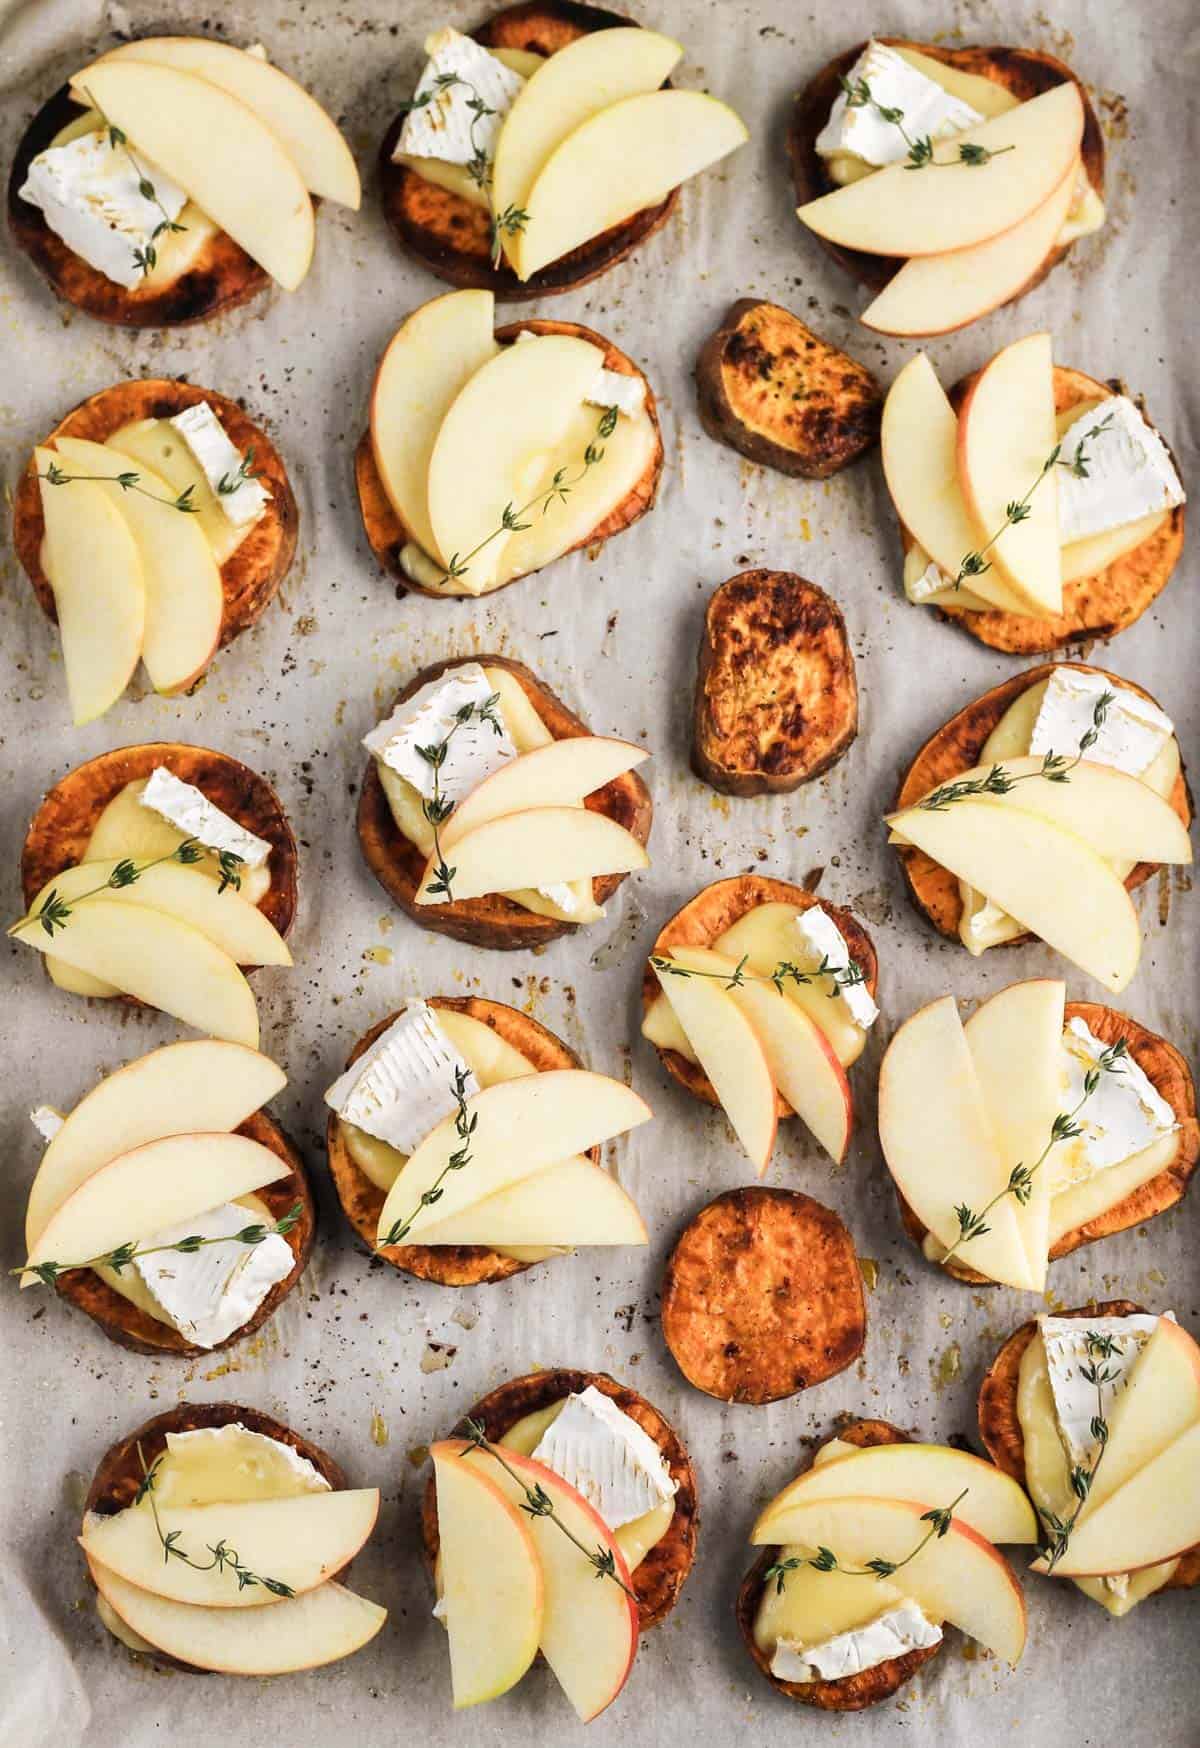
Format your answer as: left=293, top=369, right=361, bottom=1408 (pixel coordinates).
left=817, top=42, right=983, bottom=166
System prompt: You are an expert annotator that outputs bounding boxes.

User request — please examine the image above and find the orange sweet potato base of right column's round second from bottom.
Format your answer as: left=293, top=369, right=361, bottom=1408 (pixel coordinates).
left=897, top=1002, right=1200, bottom=1287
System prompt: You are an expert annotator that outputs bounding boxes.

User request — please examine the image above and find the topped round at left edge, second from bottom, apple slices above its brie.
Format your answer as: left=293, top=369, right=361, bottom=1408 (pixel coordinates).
left=17, top=1038, right=317, bottom=1356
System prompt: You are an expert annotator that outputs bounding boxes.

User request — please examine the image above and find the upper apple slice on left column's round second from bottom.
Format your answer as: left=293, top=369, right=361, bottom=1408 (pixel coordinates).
left=24, top=1038, right=287, bottom=1248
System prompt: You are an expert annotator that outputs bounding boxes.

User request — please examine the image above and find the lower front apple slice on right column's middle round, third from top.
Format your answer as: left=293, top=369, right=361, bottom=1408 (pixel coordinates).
left=887, top=800, right=1149, bottom=993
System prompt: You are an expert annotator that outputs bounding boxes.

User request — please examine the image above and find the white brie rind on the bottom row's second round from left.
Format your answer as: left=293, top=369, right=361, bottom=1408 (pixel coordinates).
left=532, top=1384, right=679, bottom=1530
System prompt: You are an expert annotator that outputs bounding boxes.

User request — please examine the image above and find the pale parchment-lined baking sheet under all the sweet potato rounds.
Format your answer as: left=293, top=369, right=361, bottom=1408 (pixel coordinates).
left=0, top=0, right=1200, bottom=1748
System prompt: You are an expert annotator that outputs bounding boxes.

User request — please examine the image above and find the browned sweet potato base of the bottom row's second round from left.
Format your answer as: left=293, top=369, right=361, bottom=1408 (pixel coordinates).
left=422, top=1367, right=700, bottom=1631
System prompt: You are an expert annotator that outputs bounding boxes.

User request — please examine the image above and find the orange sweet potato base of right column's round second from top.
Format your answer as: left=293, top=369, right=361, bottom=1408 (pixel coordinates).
left=923, top=364, right=1184, bottom=656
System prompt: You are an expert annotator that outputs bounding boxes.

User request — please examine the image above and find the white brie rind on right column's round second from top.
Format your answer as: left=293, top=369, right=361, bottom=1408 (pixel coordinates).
left=1058, top=395, right=1186, bottom=545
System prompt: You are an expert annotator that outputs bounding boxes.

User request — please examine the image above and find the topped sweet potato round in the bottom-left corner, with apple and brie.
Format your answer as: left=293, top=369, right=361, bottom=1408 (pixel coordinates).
left=79, top=1402, right=387, bottom=1676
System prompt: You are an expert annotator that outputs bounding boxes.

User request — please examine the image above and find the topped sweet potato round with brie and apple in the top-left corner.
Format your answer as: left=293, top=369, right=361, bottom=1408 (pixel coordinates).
left=9, top=37, right=362, bottom=329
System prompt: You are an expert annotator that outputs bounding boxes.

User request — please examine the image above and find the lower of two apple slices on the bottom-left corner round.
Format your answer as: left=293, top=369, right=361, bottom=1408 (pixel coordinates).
left=89, top=1561, right=388, bottom=1675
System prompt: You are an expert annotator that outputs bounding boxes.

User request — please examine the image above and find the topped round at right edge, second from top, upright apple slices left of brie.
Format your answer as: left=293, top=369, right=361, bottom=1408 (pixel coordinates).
left=882, top=334, right=1184, bottom=656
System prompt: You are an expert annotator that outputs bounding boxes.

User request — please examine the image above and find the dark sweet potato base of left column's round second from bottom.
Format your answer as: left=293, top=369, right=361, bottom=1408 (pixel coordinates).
left=54, top=1110, right=317, bottom=1360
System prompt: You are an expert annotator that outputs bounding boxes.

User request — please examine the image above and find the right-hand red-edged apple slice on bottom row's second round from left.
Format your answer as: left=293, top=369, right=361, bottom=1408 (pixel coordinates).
left=454, top=1446, right=638, bottom=1724
